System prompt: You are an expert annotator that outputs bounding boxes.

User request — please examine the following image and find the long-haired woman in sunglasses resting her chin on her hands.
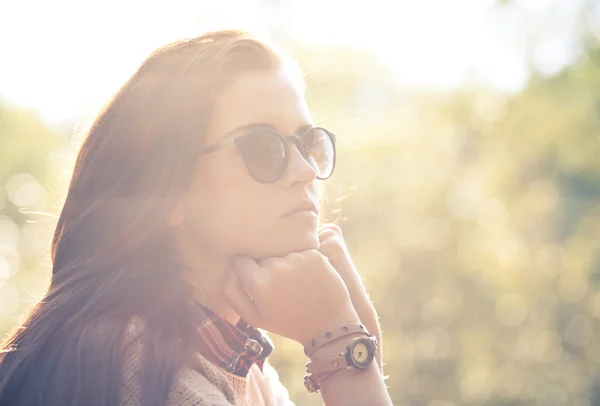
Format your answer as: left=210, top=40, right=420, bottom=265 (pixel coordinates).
left=0, top=31, right=391, bottom=406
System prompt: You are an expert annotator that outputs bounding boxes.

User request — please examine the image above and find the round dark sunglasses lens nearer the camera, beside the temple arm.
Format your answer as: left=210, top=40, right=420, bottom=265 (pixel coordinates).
left=235, top=130, right=285, bottom=183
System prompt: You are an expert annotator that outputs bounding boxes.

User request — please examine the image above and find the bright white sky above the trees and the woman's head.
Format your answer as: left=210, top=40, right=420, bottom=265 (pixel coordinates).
left=0, top=0, right=583, bottom=122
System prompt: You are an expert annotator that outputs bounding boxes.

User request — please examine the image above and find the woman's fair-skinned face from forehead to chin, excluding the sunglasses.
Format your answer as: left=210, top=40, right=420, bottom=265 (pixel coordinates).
left=176, top=70, right=319, bottom=258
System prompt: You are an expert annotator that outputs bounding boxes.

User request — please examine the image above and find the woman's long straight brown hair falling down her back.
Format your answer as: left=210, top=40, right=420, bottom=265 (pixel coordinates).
left=0, top=31, right=283, bottom=406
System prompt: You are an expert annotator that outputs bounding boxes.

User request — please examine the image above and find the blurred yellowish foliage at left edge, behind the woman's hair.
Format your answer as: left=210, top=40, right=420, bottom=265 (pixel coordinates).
left=0, top=103, right=68, bottom=333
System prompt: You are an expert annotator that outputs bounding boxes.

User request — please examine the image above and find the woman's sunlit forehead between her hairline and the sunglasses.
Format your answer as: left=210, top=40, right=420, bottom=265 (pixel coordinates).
left=207, top=70, right=311, bottom=142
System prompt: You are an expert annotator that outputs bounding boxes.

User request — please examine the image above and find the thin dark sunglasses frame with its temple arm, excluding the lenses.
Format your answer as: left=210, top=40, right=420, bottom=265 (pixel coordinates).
left=199, top=126, right=337, bottom=183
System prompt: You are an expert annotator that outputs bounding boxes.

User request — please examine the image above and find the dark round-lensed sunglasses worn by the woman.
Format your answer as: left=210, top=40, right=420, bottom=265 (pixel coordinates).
left=200, top=127, right=336, bottom=183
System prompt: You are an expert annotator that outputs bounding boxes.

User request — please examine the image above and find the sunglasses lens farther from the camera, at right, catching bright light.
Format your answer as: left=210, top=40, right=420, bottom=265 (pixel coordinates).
left=302, top=128, right=335, bottom=179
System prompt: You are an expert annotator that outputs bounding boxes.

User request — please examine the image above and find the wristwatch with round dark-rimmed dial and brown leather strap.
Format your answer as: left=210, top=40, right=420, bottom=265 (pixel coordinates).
left=304, top=336, right=378, bottom=393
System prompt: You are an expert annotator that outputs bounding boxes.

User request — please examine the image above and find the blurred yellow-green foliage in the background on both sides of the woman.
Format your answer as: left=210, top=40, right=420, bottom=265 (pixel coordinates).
left=0, top=32, right=600, bottom=406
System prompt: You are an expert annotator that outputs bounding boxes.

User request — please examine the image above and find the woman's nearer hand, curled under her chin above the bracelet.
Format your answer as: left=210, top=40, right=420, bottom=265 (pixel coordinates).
left=223, top=250, right=360, bottom=344
